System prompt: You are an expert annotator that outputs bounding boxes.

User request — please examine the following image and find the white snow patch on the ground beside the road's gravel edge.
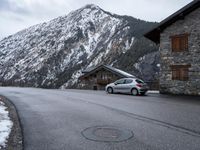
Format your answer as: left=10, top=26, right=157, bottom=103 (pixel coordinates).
left=0, top=101, right=13, bottom=147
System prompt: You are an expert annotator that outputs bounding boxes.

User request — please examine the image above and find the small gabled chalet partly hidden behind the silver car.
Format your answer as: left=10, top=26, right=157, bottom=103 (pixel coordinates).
left=79, top=65, right=135, bottom=90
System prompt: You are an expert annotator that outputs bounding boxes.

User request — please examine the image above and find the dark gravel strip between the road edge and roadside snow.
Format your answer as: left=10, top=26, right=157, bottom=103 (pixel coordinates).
left=0, top=95, right=23, bottom=150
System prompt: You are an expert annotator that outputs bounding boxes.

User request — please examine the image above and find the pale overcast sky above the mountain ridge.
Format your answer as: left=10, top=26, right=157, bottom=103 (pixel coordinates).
left=0, top=0, right=192, bottom=40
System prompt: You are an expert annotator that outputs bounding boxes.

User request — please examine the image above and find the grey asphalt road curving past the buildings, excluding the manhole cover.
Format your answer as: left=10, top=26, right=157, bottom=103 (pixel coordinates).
left=0, top=87, right=200, bottom=150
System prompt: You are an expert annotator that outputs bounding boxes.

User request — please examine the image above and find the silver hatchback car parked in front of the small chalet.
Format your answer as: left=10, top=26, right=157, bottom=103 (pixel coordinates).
left=106, top=78, right=149, bottom=95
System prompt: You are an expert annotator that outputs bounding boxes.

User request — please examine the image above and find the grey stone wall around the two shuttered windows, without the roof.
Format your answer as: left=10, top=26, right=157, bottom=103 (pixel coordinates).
left=160, top=8, right=200, bottom=95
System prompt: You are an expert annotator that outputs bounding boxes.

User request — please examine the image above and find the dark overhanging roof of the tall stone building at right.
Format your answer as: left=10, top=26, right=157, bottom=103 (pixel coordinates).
left=144, top=0, right=200, bottom=44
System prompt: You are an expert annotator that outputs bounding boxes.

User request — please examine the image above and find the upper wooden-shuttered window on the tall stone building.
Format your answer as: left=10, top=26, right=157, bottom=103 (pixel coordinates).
left=171, top=34, right=189, bottom=52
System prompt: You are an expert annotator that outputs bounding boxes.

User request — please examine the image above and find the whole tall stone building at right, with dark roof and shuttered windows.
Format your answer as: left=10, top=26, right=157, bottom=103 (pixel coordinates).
left=145, top=0, right=200, bottom=95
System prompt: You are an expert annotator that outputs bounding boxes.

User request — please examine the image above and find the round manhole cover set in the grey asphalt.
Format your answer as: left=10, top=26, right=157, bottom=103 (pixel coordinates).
left=82, top=126, right=133, bottom=142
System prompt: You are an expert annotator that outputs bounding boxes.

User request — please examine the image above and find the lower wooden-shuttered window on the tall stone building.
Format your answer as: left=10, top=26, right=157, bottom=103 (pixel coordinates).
left=171, top=65, right=191, bottom=81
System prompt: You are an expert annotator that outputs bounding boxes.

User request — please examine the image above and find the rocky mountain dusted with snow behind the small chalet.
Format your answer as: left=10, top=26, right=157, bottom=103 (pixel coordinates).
left=0, top=5, right=157, bottom=88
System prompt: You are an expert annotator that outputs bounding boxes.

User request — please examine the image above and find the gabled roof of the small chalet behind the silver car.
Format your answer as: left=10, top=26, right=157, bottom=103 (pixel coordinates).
left=80, top=65, right=135, bottom=78
